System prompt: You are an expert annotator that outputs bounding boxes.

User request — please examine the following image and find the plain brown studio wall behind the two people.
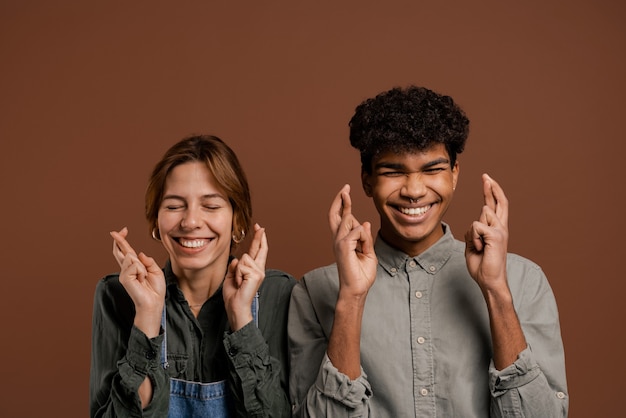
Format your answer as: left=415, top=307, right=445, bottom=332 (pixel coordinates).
left=0, top=0, right=626, bottom=418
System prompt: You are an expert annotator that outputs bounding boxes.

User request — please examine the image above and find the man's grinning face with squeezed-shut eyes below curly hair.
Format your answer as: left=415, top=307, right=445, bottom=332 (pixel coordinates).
left=362, top=144, right=459, bottom=256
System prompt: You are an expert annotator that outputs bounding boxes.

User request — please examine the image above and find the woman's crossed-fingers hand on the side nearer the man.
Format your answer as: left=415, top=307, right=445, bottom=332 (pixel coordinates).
left=222, top=224, right=268, bottom=331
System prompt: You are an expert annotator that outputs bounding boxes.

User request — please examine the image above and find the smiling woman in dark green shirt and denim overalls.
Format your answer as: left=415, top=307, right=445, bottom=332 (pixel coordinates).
left=90, top=136, right=295, bottom=417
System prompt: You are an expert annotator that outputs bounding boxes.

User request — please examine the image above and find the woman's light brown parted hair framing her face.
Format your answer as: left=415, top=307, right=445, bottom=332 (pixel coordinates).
left=146, top=135, right=252, bottom=245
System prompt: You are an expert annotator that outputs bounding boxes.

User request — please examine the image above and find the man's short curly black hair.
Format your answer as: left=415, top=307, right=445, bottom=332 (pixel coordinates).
left=349, top=86, right=469, bottom=173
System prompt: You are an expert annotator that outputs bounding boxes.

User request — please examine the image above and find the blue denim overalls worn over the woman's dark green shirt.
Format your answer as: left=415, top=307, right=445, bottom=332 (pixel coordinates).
left=161, top=293, right=259, bottom=418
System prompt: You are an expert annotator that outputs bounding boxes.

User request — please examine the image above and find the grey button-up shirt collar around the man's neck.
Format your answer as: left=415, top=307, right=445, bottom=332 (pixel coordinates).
left=374, top=222, right=455, bottom=276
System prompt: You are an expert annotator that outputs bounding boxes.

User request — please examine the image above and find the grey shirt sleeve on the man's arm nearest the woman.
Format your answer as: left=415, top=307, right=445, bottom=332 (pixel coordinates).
left=288, top=279, right=372, bottom=418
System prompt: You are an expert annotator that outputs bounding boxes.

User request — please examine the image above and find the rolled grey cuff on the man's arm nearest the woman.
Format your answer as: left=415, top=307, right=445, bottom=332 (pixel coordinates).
left=315, top=354, right=372, bottom=408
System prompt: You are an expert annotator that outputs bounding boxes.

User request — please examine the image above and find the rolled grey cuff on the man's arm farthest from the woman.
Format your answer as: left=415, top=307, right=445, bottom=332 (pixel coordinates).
left=489, top=347, right=541, bottom=397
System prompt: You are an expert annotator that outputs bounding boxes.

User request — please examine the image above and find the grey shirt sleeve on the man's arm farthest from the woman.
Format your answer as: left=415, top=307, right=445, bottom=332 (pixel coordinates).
left=489, top=259, right=569, bottom=418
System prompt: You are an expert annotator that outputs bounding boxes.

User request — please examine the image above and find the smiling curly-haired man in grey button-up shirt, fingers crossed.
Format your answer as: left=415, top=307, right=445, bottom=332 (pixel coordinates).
left=289, top=86, right=568, bottom=418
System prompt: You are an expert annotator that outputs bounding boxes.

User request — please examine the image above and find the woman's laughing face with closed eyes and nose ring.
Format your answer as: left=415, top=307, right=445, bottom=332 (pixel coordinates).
left=157, top=161, right=233, bottom=278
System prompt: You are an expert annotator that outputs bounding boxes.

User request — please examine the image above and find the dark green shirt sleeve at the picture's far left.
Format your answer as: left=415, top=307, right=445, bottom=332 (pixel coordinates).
left=89, top=276, right=169, bottom=418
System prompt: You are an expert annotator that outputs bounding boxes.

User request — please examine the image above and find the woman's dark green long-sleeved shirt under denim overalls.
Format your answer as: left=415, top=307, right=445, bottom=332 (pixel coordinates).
left=89, top=263, right=295, bottom=417
